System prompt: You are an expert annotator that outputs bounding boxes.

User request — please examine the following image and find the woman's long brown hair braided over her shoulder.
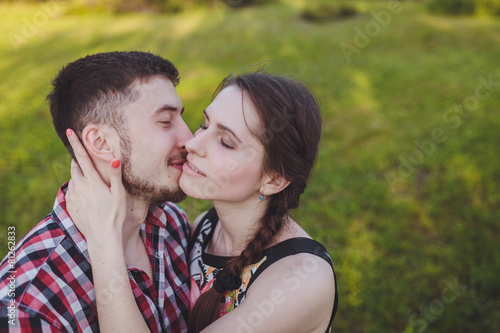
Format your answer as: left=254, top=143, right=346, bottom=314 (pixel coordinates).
left=188, top=71, right=322, bottom=333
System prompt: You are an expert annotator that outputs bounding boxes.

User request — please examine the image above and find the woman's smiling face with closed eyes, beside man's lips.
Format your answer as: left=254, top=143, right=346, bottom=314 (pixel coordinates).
left=179, top=85, right=264, bottom=203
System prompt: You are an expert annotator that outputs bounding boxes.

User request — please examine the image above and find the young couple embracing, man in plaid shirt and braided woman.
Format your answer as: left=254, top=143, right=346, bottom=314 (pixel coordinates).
left=0, top=52, right=337, bottom=332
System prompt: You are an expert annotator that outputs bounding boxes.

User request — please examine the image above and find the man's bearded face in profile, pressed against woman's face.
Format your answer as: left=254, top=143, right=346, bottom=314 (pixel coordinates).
left=121, top=77, right=193, bottom=204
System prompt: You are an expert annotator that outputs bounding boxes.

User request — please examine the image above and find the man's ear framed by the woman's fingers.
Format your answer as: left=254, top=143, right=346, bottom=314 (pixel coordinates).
left=81, top=124, right=116, bottom=162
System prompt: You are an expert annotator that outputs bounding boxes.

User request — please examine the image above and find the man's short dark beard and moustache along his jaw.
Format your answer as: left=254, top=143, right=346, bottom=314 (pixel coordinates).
left=121, top=138, right=186, bottom=205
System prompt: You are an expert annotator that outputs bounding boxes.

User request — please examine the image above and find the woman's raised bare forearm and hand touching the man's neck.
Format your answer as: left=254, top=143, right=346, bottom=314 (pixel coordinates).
left=66, top=131, right=149, bottom=333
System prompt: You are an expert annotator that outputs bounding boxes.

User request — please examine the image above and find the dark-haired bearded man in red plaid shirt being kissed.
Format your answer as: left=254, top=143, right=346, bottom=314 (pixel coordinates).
left=0, top=52, right=192, bottom=332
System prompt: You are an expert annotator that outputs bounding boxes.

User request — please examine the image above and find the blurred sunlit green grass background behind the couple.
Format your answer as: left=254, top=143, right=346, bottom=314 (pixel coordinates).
left=0, top=0, right=500, bottom=332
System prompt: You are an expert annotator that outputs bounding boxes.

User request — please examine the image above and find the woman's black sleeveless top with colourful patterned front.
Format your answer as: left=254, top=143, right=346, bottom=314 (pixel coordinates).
left=189, top=208, right=338, bottom=333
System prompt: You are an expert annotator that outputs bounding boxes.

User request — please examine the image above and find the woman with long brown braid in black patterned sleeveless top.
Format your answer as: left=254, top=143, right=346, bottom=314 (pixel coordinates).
left=66, top=72, right=337, bottom=332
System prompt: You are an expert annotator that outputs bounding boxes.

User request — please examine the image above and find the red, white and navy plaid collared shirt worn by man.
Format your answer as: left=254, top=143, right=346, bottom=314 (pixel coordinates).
left=0, top=184, right=190, bottom=332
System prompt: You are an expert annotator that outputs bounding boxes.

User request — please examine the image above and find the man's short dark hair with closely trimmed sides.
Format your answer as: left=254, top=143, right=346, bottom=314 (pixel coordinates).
left=47, top=51, right=179, bottom=158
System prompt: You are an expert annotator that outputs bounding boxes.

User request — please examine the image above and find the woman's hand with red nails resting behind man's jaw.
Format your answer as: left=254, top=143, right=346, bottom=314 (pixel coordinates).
left=66, top=129, right=126, bottom=245
